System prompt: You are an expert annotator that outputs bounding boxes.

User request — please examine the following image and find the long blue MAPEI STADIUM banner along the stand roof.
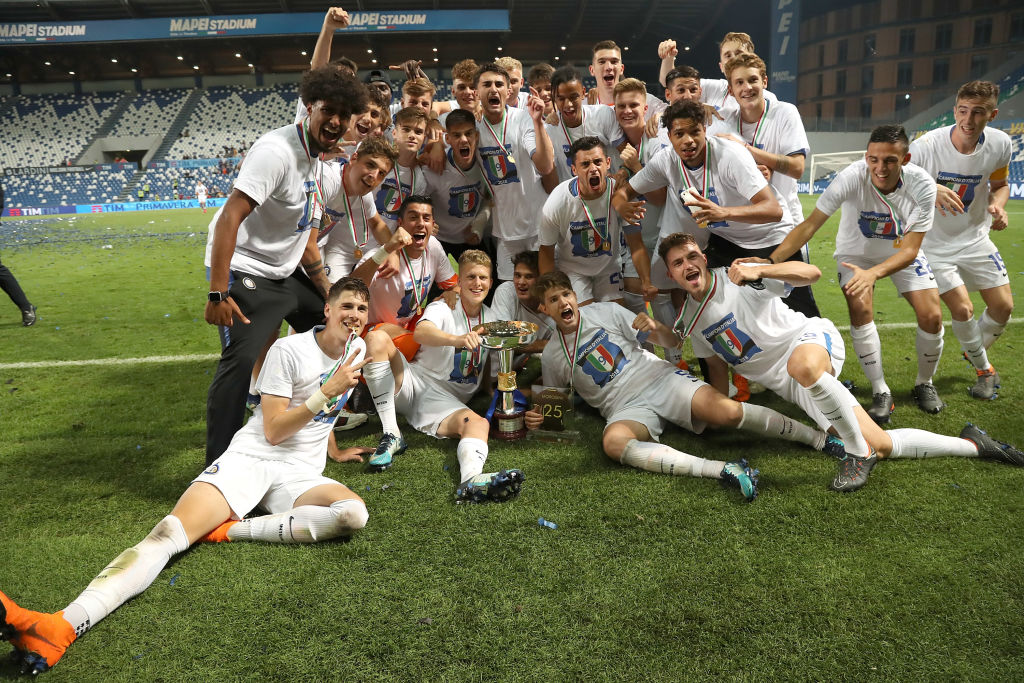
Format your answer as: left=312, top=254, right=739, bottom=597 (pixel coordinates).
left=0, top=9, right=509, bottom=45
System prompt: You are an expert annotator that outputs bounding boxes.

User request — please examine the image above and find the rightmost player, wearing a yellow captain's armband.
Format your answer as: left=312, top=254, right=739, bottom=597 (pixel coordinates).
left=910, top=81, right=1014, bottom=399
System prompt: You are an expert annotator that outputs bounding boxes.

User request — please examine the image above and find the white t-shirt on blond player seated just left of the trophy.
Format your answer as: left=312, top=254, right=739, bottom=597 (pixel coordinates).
left=412, top=301, right=497, bottom=403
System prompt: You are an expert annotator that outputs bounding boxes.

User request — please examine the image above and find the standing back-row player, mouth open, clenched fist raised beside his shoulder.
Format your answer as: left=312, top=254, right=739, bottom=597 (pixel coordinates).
left=475, top=63, right=555, bottom=281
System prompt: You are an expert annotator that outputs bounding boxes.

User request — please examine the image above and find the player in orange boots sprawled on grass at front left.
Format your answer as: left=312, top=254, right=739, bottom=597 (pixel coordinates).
left=0, top=278, right=369, bottom=674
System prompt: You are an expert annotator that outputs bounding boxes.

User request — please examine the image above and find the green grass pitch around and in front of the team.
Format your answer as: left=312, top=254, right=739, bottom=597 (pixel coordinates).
left=0, top=197, right=1024, bottom=681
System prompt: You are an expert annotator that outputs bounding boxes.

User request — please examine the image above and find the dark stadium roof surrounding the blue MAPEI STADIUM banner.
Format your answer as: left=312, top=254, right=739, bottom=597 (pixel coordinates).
left=0, top=0, right=769, bottom=83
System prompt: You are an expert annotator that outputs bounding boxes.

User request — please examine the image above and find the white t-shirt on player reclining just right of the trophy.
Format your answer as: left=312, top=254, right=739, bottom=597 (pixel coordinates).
left=541, top=303, right=675, bottom=418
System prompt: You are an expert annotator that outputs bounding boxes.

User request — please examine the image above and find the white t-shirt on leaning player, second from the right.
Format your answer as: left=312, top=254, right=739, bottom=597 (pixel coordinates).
left=816, top=159, right=935, bottom=262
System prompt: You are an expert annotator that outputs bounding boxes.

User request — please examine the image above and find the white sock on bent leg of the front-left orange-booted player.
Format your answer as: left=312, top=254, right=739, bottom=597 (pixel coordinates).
left=227, top=498, right=370, bottom=543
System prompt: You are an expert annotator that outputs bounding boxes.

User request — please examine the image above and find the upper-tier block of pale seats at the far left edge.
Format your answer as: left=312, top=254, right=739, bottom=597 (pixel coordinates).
left=0, top=92, right=122, bottom=168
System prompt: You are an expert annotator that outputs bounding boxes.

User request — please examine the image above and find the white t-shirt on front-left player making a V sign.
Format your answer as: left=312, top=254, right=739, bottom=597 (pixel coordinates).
left=227, top=327, right=367, bottom=472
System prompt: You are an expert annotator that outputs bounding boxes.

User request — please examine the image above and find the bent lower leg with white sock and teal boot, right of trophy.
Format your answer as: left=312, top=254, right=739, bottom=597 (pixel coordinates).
left=601, top=419, right=758, bottom=501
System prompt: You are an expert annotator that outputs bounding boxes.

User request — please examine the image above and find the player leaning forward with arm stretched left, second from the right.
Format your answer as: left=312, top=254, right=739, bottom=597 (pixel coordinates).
left=768, top=125, right=945, bottom=424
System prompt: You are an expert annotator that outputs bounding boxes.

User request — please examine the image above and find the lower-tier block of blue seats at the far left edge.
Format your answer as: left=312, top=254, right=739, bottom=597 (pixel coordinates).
left=3, top=165, right=134, bottom=208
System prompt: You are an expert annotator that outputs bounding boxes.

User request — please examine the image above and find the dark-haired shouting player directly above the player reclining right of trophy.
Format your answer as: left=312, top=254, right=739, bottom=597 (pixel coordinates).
left=540, top=136, right=657, bottom=305
